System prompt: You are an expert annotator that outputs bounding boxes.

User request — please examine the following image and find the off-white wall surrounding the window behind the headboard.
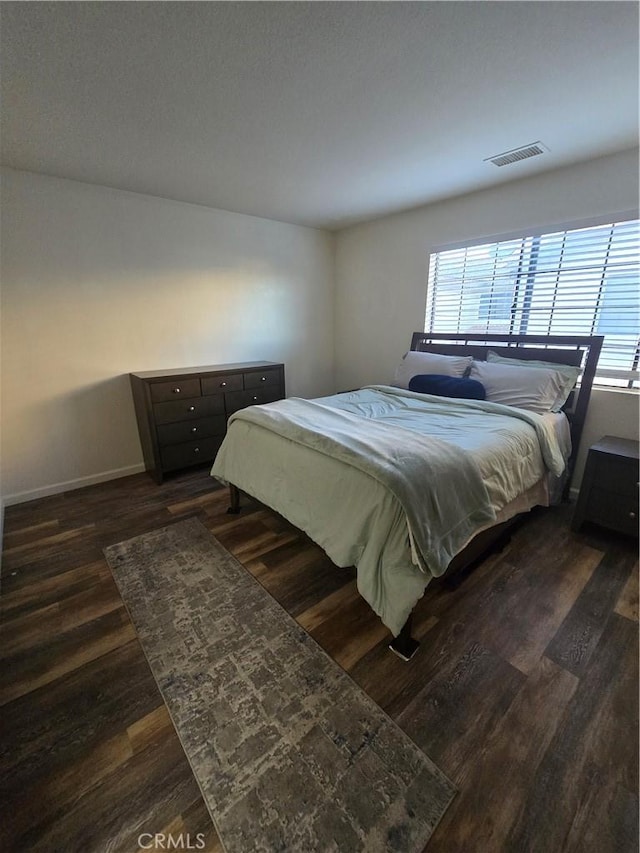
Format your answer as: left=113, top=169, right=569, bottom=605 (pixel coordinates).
left=335, top=150, right=638, bottom=486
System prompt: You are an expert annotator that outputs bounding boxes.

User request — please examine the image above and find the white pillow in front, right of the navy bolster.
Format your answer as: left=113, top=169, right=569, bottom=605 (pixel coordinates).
left=469, top=361, right=565, bottom=415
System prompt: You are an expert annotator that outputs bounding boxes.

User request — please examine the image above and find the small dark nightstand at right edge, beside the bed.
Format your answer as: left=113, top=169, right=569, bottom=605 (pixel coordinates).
left=571, top=435, right=639, bottom=536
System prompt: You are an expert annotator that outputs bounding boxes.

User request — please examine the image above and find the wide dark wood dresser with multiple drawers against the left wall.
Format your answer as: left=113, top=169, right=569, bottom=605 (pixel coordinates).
left=129, top=361, right=285, bottom=483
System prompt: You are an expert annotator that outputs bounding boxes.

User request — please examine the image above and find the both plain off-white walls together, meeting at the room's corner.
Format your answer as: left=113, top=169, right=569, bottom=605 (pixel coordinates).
left=0, top=152, right=638, bottom=503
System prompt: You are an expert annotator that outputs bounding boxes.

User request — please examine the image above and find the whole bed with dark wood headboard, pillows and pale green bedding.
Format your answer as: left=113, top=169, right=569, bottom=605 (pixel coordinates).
left=211, top=332, right=603, bottom=659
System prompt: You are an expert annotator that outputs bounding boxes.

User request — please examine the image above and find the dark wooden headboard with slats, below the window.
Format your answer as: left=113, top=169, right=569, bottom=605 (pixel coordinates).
left=411, top=332, right=604, bottom=475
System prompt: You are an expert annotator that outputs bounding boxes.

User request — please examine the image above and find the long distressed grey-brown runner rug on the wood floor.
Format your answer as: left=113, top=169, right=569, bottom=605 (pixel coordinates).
left=105, top=518, right=455, bottom=853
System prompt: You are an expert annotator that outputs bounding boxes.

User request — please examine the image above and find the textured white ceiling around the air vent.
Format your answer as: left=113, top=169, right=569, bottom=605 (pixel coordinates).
left=0, top=0, right=638, bottom=229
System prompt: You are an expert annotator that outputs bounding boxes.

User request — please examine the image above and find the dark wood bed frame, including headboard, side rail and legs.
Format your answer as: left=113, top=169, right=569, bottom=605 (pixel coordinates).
left=228, top=332, right=604, bottom=660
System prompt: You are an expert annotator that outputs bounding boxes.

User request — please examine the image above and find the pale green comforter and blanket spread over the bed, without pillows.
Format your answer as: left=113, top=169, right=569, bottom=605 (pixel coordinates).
left=211, top=385, right=570, bottom=634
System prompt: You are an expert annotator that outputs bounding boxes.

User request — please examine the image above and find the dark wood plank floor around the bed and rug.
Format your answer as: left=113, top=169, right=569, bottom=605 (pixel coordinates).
left=0, top=469, right=638, bottom=853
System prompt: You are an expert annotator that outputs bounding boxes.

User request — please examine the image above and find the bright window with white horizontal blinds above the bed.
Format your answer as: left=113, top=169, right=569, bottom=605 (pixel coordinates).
left=425, top=220, right=640, bottom=388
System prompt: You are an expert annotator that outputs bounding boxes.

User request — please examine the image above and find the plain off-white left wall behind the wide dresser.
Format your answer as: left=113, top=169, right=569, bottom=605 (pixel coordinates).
left=0, top=169, right=334, bottom=503
